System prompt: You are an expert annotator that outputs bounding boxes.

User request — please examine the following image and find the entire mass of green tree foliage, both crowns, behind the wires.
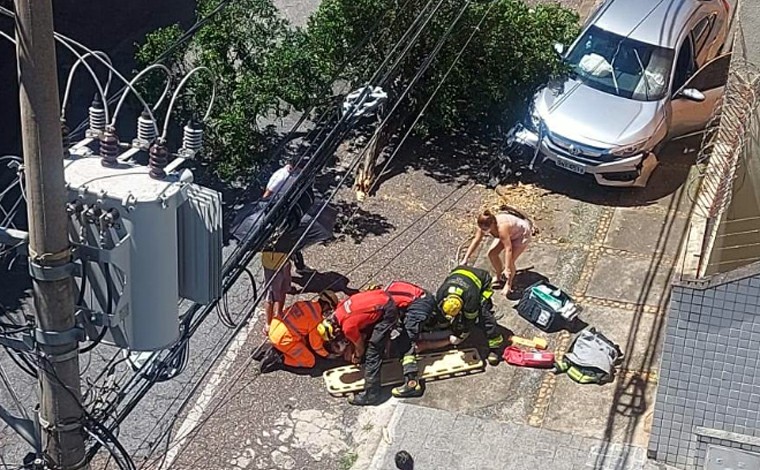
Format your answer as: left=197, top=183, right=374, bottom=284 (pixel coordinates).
left=136, top=0, right=578, bottom=179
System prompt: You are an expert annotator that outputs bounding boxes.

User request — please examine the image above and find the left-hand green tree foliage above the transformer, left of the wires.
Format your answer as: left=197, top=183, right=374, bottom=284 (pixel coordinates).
left=136, top=0, right=299, bottom=179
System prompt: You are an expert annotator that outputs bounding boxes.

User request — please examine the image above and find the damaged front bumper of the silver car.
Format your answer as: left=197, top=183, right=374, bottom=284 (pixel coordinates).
left=508, top=124, right=658, bottom=187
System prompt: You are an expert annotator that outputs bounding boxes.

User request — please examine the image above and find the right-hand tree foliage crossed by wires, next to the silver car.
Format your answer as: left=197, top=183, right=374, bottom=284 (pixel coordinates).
left=296, top=0, right=578, bottom=131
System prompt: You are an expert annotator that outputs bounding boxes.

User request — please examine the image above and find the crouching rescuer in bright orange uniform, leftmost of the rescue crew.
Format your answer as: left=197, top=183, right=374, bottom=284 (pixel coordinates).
left=269, top=291, right=338, bottom=368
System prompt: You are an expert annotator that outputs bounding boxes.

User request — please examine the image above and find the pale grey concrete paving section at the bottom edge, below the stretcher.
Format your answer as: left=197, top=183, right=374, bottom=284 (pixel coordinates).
left=368, top=403, right=660, bottom=470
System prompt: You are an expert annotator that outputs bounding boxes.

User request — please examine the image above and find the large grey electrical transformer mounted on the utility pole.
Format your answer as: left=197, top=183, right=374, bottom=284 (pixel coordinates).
left=64, top=146, right=223, bottom=351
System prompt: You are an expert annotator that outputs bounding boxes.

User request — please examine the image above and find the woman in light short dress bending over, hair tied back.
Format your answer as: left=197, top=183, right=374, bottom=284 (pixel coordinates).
left=461, top=205, right=535, bottom=295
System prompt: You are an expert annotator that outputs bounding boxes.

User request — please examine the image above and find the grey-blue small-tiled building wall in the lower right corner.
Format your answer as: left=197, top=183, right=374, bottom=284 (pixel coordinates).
left=649, top=263, right=760, bottom=469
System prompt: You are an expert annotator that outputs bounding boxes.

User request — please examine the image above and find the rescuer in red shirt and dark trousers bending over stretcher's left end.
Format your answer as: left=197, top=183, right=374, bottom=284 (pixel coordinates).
left=317, top=289, right=399, bottom=405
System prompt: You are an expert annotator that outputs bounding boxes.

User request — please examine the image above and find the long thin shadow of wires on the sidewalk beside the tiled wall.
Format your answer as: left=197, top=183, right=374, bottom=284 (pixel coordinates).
left=594, top=167, right=693, bottom=468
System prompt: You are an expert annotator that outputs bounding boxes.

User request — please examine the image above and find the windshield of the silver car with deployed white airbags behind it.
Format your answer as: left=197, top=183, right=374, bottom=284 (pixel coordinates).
left=566, top=26, right=675, bottom=101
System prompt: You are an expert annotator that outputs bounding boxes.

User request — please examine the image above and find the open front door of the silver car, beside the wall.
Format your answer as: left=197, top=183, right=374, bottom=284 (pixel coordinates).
left=669, top=53, right=731, bottom=138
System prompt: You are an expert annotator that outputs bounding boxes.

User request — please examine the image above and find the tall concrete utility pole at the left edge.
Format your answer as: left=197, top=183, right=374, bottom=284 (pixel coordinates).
left=14, top=0, right=85, bottom=470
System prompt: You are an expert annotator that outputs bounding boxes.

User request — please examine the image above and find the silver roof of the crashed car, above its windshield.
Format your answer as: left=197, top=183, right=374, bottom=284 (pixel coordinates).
left=593, top=0, right=704, bottom=49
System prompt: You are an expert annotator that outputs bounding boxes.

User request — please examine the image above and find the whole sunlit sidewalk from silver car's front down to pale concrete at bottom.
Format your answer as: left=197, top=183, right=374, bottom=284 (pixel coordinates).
left=353, top=143, right=691, bottom=470
